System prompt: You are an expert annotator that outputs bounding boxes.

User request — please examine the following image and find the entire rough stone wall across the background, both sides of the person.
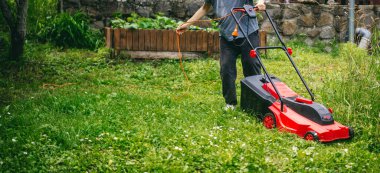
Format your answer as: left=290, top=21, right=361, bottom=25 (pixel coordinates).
left=64, top=0, right=380, bottom=44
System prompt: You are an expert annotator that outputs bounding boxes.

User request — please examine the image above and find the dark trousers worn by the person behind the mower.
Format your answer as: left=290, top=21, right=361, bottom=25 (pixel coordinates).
left=220, top=31, right=261, bottom=105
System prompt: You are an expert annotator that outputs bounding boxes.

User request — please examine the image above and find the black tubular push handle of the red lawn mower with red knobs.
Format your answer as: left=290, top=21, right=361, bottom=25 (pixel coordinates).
left=231, top=7, right=314, bottom=111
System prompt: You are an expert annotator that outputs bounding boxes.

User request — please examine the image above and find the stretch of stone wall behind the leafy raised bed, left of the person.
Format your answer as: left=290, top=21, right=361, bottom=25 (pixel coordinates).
left=63, top=0, right=204, bottom=19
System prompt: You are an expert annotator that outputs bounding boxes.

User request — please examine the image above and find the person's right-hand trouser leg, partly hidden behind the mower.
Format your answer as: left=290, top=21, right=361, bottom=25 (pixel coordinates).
left=241, top=31, right=261, bottom=77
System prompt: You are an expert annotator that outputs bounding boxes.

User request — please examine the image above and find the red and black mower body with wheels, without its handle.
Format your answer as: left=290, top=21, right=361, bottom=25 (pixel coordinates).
left=241, top=75, right=353, bottom=142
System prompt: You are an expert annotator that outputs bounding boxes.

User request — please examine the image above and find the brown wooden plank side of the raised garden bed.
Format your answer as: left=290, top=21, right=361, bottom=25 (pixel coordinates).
left=105, top=28, right=267, bottom=58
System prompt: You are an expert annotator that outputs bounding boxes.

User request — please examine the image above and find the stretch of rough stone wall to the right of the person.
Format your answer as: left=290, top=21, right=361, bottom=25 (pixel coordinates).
left=261, top=3, right=380, bottom=44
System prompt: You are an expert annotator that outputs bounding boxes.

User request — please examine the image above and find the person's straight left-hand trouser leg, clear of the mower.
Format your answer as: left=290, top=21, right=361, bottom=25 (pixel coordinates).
left=220, top=37, right=239, bottom=105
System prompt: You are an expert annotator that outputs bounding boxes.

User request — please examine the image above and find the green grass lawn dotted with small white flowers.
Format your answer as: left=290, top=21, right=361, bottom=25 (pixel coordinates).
left=0, top=44, right=380, bottom=172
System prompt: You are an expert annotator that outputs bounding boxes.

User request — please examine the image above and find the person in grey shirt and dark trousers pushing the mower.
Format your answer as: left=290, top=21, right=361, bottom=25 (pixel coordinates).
left=177, top=0, right=266, bottom=110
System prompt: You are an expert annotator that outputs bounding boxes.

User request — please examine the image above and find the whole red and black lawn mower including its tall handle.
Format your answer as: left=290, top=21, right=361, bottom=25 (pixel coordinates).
left=231, top=5, right=354, bottom=142
